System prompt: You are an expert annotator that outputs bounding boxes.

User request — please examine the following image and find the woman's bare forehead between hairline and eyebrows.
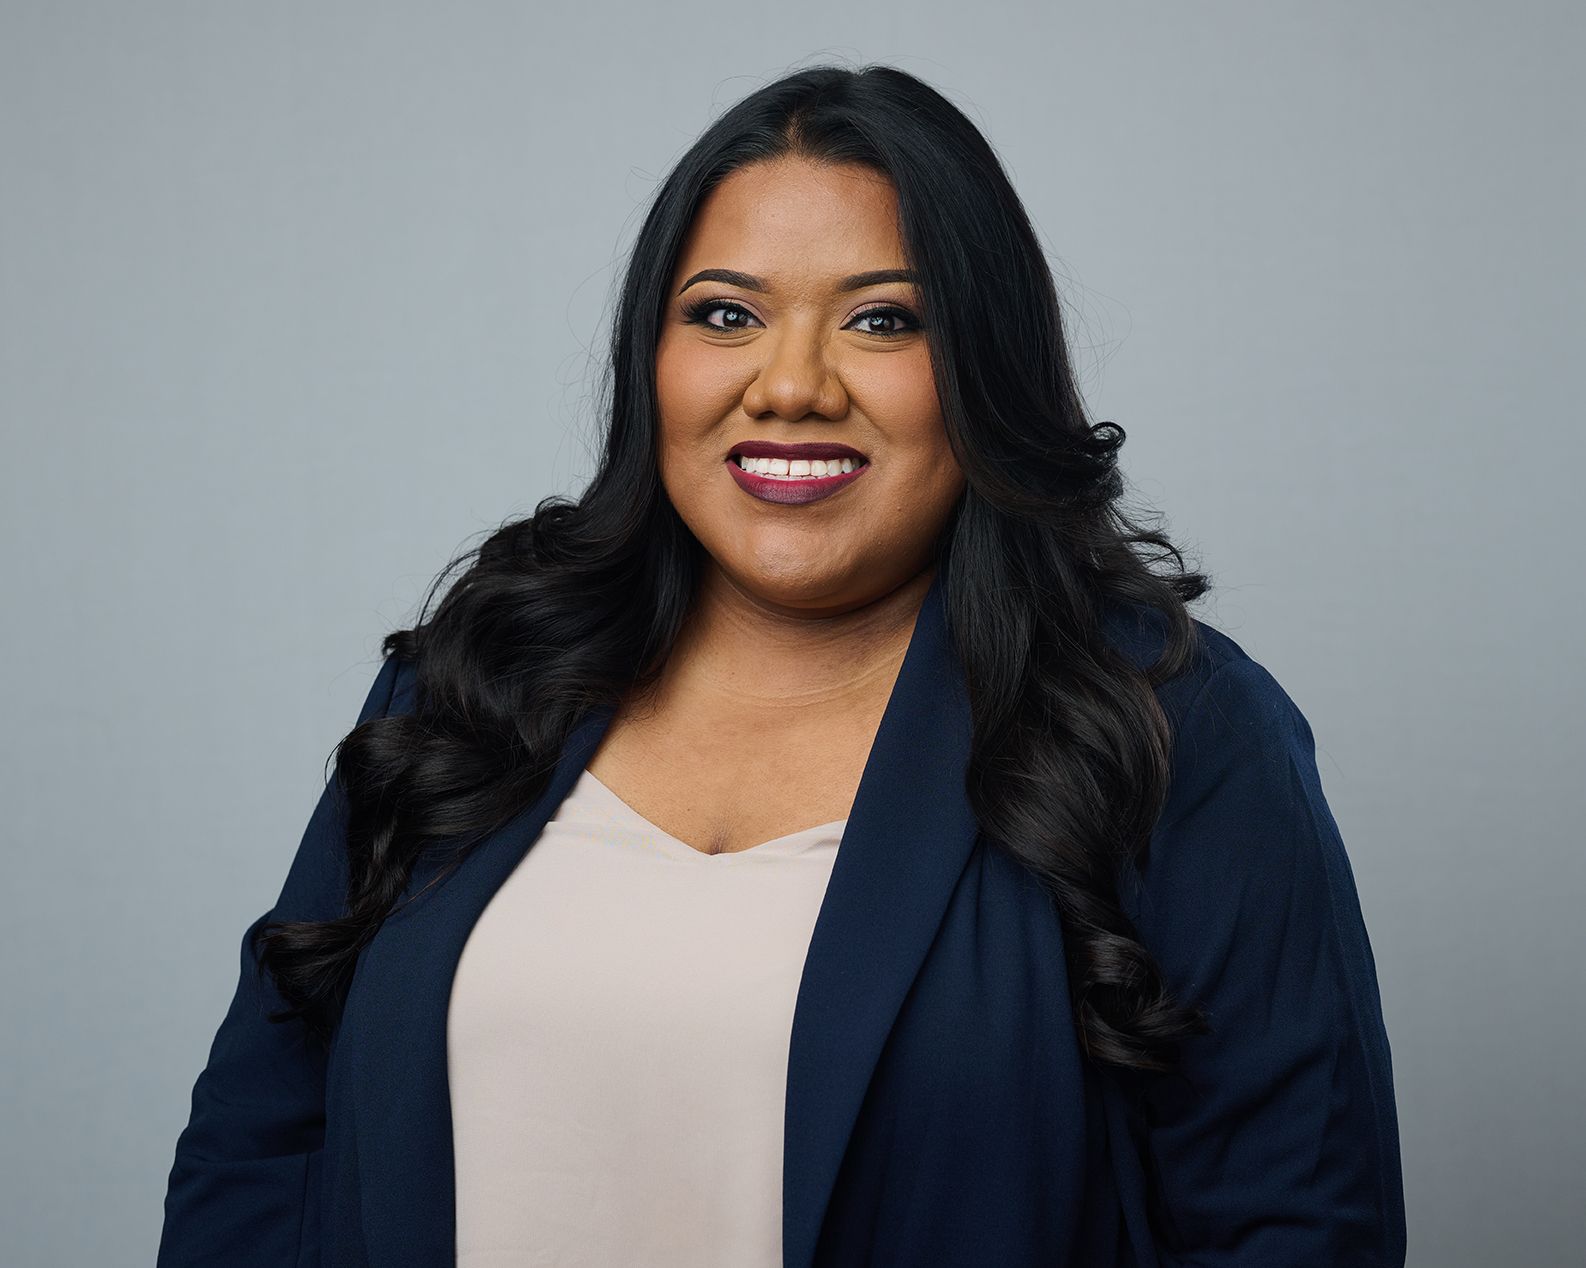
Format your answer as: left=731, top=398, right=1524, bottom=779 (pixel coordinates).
left=674, top=159, right=904, bottom=289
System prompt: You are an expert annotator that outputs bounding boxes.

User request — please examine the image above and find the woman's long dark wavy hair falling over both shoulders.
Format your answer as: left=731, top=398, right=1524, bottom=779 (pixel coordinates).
left=257, top=65, right=1209, bottom=1070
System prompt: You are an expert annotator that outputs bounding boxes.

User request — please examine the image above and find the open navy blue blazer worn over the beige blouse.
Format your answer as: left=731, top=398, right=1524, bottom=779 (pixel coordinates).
left=159, top=571, right=1405, bottom=1268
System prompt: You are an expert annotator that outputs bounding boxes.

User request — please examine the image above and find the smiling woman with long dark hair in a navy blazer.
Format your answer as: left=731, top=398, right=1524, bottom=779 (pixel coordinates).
left=160, top=67, right=1405, bottom=1268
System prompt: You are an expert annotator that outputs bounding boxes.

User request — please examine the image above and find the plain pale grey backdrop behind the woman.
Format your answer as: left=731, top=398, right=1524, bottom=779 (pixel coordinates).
left=0, top=0, right=1586, bottom=1268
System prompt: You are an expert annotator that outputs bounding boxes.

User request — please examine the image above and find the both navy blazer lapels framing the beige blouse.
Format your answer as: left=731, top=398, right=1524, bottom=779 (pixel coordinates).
left=347, top=560, right=977, bottom=1268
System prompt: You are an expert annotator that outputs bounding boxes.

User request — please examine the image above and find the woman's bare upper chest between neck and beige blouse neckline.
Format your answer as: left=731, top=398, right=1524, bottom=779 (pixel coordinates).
left=588, top=688, right=887, bottom=854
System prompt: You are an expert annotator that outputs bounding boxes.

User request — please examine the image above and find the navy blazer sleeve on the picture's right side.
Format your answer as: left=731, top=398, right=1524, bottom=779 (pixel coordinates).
left=1137, top=657, right=1405, bottom=1268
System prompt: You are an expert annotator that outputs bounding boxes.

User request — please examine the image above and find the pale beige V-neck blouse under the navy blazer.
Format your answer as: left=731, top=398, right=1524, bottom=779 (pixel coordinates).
left=447, top=770, right=847, bottom=1268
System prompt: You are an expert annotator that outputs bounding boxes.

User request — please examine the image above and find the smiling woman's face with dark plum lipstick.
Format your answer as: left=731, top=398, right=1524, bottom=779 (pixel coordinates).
left=655, top=160, right=964, bottom=614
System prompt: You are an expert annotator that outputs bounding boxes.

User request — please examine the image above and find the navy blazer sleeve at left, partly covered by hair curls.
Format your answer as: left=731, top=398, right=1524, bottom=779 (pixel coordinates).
left=157, top=655, right=398, bottom=1268
